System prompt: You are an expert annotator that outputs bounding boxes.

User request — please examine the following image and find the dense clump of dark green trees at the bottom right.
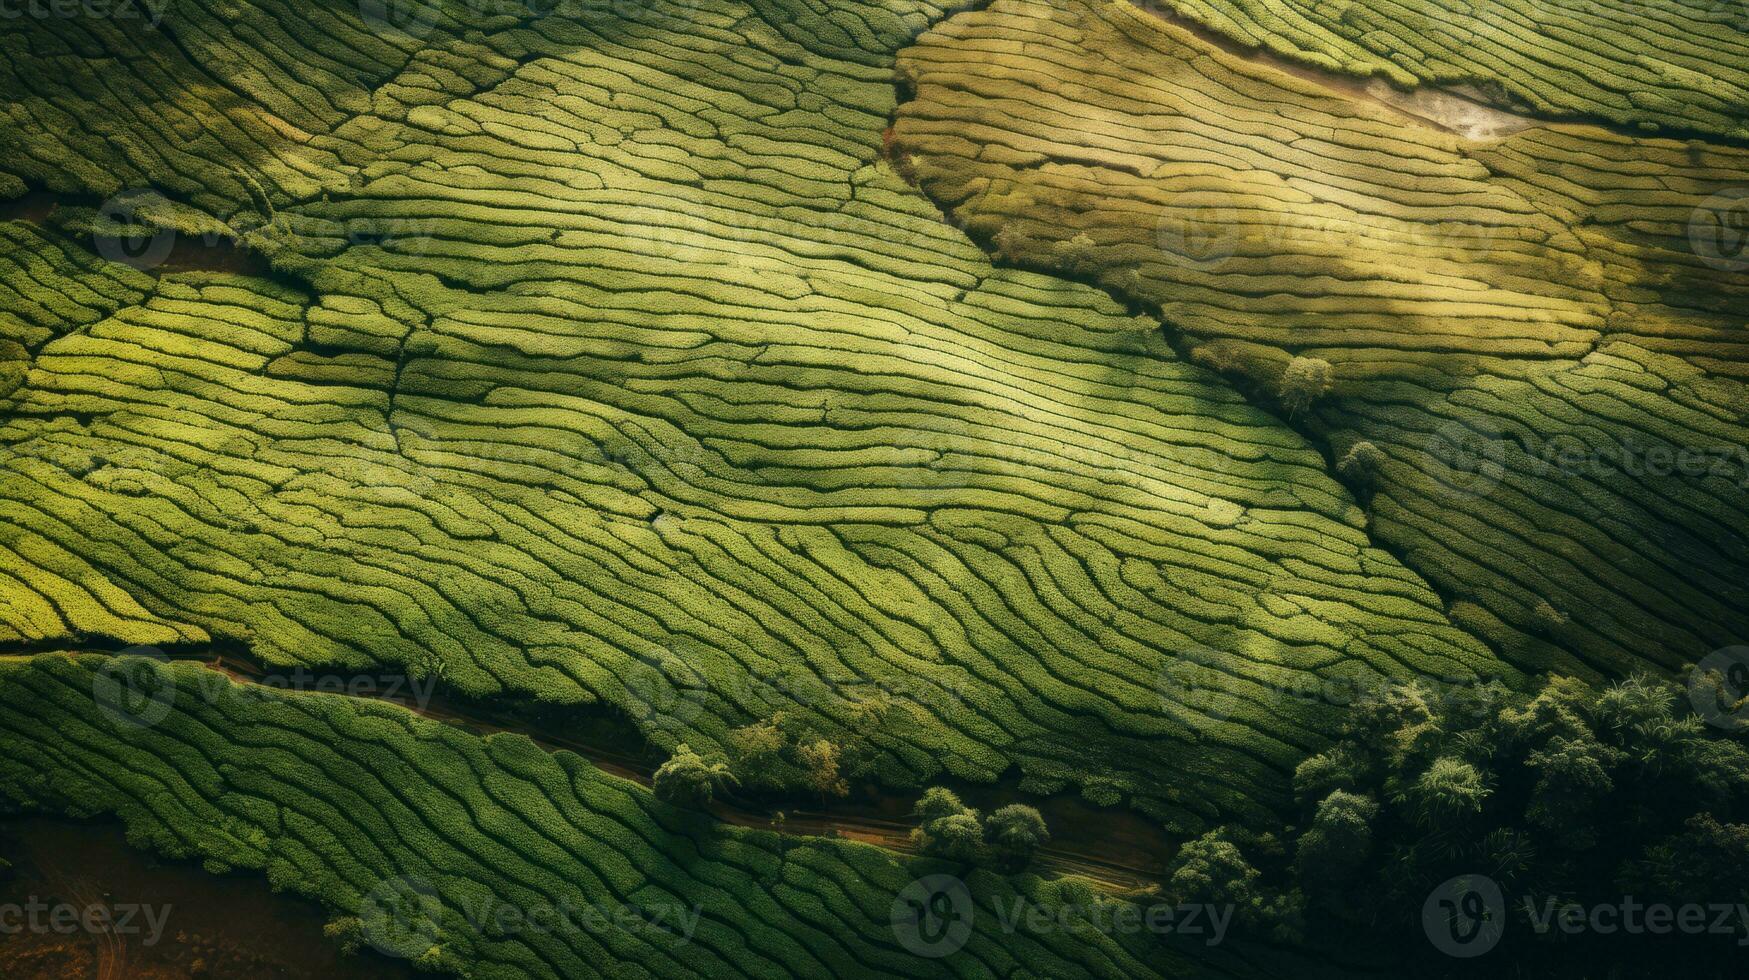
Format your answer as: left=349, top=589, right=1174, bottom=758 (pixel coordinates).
left=1273, top=677, right=1749, bottom=963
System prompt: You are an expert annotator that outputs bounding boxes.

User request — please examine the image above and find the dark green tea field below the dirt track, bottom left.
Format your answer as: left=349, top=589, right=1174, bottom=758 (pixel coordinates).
left=0, top=655, right=1280, bottom=980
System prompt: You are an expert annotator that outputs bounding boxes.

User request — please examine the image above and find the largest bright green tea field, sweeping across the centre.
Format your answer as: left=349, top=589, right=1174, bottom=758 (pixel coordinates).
left=0, top=2, right=1504, bottom=831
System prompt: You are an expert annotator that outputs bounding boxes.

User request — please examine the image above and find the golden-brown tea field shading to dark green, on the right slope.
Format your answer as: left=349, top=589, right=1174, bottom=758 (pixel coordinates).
left=892, top=0, right=1749, bottom=674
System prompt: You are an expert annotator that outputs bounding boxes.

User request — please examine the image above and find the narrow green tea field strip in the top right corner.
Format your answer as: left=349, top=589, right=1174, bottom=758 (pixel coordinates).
left=1149, top=0, right=1749, bottom=140
